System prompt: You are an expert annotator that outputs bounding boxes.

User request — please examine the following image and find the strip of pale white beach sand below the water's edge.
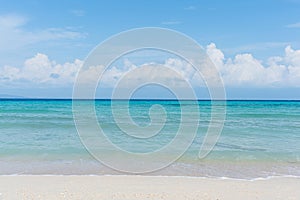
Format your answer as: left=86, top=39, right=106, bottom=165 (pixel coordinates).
left=0, top=176, right=300, bottom=200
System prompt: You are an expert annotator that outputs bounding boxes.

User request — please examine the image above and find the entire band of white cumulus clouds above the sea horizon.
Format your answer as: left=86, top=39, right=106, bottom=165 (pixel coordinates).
left=0, top=43, right=300, bottom=88
